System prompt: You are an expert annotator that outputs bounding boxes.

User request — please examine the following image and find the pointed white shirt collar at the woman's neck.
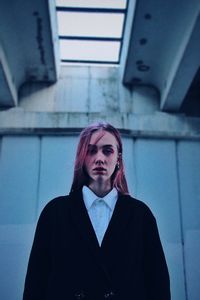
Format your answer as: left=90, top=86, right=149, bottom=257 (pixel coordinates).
left=82, top=185, right=118, bottom=211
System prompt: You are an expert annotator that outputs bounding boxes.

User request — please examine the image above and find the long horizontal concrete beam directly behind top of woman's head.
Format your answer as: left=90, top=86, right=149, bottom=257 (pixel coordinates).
left=0, top=108, right=200, bottom=140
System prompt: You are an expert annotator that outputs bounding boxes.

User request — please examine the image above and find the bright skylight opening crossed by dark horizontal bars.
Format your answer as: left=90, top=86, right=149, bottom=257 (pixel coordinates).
left=56, top=0, right=126, bottom=64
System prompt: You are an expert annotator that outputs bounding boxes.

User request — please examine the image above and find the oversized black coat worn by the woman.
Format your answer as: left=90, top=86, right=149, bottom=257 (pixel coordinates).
left=23, top=191, right=170, bottom=300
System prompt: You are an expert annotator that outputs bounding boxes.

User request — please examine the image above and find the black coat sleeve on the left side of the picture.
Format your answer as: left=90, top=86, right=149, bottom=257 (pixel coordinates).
left=23, top=200, right=53, bottom=300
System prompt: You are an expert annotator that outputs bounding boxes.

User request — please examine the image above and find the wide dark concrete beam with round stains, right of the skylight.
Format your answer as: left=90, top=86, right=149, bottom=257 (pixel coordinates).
left=121, top=0, right=200, bottom=111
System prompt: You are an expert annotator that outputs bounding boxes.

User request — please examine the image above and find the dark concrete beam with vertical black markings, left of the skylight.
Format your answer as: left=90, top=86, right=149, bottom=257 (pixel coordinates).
left=0, top=0, right=60, bottom=107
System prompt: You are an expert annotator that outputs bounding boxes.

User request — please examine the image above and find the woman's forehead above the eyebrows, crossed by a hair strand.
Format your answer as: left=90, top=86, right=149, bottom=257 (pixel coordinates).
left=90, top=130, right=118, bottom=146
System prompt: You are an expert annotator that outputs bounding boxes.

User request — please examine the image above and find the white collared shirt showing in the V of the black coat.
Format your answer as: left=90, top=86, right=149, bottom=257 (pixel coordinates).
left=82, top=186, right=118, bottom=245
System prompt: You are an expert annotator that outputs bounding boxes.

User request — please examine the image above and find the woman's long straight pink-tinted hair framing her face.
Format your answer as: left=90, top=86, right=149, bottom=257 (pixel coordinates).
left=71, top=122, right=129, bottom=194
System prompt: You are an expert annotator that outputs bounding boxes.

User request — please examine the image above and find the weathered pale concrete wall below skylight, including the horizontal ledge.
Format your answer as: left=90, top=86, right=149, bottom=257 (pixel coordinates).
left=0, top=66, right=200, bottom=139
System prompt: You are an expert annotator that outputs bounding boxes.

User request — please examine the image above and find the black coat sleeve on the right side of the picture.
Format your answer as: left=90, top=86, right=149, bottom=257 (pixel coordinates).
left=144, top=210, right=171, bottom=300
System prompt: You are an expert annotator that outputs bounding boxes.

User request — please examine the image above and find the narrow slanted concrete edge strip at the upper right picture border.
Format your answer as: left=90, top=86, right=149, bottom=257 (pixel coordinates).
left=160, top=15, right=200, bottom=111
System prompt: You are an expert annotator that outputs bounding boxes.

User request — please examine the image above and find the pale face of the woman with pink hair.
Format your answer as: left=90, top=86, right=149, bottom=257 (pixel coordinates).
left=85, top=130, right=118, bottom=183
